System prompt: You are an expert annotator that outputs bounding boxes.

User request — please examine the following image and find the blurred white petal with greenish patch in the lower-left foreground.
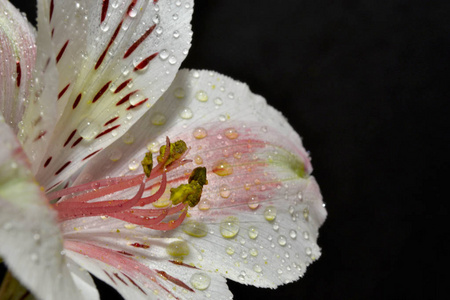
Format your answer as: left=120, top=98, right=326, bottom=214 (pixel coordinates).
left=0, top=115, right=90, bottom=299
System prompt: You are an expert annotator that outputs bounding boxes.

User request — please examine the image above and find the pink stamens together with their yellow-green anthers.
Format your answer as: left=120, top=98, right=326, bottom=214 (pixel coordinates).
left=47, top=138, right=208, bottom=230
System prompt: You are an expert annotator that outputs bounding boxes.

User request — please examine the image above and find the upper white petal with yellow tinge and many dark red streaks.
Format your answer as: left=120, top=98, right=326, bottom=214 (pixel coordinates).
left=31, top=0, right=193, bottom=188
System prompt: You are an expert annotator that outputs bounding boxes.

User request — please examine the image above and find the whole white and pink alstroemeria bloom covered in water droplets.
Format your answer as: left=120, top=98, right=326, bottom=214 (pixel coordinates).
left=0, top=0, right=326, bottom=299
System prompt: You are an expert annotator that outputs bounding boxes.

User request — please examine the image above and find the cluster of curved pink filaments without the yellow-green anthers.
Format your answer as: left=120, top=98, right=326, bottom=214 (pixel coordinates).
left=52, top=138, right=188, bottom=230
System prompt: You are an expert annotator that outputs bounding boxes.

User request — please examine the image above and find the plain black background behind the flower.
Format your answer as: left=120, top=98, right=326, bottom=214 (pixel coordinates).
left=4, top=0, right=450, bottom=300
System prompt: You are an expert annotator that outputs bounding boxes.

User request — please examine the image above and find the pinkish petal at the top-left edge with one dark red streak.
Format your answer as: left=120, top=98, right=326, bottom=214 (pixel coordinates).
left=0, top=0, right=36, bottom=133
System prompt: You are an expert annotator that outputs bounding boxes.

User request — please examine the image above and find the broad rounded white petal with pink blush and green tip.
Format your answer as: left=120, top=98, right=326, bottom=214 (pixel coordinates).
left=70, top=70, right=326, bottom=288
